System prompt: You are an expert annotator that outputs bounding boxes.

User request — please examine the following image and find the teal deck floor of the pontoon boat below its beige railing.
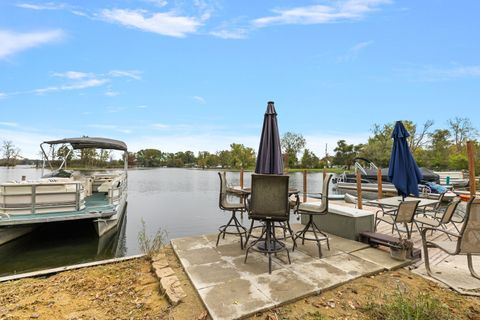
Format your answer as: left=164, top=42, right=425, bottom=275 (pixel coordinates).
left=0, top=193, right=115, bottom=226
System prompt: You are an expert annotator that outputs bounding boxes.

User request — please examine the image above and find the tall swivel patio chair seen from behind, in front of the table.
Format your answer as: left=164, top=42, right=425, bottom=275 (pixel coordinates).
left=245, top=174, right=291, bottom=273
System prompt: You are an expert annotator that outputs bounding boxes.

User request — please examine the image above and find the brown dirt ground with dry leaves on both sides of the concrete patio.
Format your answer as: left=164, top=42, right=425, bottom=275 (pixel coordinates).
left=0, top=246, right=480, bottom=320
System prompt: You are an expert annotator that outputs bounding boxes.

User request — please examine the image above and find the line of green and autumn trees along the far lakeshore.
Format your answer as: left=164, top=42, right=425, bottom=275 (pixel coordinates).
left=0, top=117, right=480, bottom=170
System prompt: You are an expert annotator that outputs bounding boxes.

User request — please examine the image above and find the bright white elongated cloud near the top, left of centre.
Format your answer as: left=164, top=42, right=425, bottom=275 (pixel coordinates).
left=100, top=9, right=202, bottom=37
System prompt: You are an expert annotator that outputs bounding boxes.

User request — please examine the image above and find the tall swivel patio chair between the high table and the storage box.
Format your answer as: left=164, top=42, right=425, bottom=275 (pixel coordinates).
left=294, top=174, right=332, bottom=258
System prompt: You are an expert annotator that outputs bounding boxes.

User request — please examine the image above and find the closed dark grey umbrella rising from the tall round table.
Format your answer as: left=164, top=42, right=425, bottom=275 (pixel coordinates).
left=255, top=101, right=283, bottom=174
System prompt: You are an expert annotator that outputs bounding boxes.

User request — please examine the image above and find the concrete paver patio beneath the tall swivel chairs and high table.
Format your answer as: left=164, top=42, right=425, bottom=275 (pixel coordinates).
left=171, top=226, right=408, bottom=319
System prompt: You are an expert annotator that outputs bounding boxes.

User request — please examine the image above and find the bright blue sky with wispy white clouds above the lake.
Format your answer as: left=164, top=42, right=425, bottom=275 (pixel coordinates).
left=0, top=0, right=480, bottom=157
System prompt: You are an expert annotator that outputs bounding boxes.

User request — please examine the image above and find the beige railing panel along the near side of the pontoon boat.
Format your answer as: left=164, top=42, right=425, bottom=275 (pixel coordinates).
left=0, top=178, right=85, bottom=216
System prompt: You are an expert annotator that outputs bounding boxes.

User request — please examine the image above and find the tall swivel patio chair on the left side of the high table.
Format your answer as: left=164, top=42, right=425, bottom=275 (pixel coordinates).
left=216, top=172, right=247, bottom=250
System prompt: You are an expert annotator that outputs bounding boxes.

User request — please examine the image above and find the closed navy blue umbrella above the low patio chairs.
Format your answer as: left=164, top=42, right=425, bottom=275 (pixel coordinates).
left=388, top=121, right=423, bottom=198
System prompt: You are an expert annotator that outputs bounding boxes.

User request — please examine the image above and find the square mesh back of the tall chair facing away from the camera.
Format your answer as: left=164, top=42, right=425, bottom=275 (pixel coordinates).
left=249, top=174, right=290, bottom=220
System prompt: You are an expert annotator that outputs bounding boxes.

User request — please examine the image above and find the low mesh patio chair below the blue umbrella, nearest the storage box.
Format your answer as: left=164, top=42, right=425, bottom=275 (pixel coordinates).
left=375, top=200, right=420, bottom=239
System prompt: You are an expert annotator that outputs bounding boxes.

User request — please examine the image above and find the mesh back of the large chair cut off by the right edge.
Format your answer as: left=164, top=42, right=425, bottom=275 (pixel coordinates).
left=458, top=197, right=480, bottom=254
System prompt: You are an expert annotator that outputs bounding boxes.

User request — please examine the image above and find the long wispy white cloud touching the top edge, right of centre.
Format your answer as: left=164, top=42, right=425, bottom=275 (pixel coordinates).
left=253, top=0, right=391, bottom=27
